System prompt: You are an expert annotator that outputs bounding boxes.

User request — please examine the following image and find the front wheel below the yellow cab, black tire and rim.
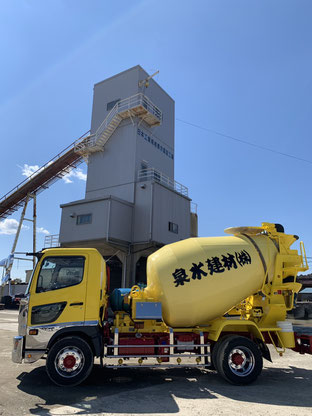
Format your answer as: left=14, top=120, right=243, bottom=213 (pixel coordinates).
left=46, top=337, right=94, bottom=386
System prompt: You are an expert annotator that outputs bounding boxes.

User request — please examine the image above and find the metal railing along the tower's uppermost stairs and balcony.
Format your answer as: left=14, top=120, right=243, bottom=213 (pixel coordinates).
left=95, top=93, right=162, bottom=141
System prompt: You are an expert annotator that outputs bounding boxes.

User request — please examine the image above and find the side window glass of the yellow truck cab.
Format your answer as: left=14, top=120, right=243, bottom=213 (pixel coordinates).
left=36, top=256, right=85, bottom=293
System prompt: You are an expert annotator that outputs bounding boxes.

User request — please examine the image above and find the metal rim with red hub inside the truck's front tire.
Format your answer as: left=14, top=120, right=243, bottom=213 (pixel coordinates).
left=54, top=347, right=85, bottom=377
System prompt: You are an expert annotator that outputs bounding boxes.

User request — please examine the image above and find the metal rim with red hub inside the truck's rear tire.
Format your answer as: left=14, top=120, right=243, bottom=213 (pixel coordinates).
left=228, top=346, right=255, bottom=377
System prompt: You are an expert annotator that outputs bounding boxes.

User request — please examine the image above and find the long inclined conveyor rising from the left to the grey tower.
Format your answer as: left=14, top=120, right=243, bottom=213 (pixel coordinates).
left=0, top=132, right=89, bottom=219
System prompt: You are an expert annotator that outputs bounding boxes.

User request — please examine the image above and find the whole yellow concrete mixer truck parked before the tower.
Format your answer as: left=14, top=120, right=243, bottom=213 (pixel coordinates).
left=12, top=223, right=312, bottom=386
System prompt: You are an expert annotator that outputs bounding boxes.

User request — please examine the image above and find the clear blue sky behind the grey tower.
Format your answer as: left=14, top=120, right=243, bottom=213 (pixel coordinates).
left=0, top=0, right=312, bottom=278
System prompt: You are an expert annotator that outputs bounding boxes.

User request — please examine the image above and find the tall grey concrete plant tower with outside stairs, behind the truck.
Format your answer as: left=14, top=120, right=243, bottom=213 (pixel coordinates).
left=60, top=66, right=197, bottom=289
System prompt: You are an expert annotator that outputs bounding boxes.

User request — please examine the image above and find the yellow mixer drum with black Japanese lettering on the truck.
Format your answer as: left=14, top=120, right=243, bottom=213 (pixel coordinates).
left=144, top=229, right=278, bottom=328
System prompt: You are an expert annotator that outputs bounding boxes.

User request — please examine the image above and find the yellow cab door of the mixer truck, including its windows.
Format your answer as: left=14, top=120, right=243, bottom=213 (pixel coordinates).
left=28, top=255, right=88, bottom=329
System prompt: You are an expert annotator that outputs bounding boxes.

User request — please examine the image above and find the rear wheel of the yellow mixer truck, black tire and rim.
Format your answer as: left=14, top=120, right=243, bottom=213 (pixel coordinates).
left=216, top=335, right=263, bottom=385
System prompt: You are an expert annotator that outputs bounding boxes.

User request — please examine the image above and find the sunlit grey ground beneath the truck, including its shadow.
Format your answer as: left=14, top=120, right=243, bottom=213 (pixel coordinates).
left=0, top=311, right=312, bottom=416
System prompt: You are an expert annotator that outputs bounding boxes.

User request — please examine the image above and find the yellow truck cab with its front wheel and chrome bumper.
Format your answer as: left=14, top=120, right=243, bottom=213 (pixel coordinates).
left=13, top=248, right=107, bottom=384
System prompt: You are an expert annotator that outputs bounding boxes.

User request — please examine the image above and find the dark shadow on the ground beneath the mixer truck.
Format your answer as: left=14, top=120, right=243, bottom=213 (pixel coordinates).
left=18, top=365, right=312, bottom=415
